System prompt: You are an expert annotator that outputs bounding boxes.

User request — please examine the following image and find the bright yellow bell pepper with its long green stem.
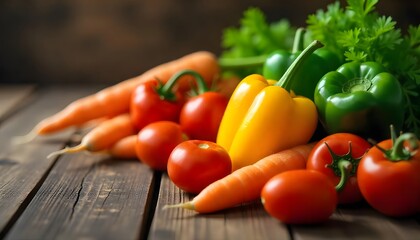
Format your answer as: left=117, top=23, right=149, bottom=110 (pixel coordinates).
left=216, top=41, right=323, bottom=171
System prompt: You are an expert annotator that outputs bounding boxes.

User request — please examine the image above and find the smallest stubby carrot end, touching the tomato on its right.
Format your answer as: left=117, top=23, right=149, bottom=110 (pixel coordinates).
left=107, top=134, right=137, bottom=159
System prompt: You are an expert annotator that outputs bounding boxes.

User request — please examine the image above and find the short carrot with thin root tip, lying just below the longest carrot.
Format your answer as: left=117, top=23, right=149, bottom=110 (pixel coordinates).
left=48, top=113, right=136, bottom=158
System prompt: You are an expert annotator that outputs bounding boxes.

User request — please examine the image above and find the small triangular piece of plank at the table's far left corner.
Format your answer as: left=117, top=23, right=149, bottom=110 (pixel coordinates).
left=0, top=84, right=35, bottom=119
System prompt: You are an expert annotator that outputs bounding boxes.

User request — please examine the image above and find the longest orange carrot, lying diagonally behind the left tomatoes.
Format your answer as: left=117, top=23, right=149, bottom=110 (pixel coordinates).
left=15, top=51, right=219, bottom=142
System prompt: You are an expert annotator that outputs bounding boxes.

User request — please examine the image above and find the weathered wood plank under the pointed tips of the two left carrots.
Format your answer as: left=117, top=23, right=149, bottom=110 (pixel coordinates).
left=0, top=86, right=104, bottom=237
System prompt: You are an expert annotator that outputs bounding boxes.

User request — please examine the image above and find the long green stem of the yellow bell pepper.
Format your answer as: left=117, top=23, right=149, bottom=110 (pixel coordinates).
left=275, top=40, right=324, bottom=91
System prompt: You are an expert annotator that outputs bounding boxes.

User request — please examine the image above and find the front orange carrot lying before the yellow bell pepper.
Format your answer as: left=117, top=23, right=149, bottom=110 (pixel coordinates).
left=164, top=143, right=314, bottom=213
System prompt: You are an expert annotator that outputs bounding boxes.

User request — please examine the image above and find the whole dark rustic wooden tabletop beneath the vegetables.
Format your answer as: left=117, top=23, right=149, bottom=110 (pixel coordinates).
left=0, top=85, right=420, bottom=240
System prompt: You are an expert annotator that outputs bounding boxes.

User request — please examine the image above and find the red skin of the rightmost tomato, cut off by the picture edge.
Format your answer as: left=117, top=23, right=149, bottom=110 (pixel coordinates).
left=357, top=139, right=420, bottom=217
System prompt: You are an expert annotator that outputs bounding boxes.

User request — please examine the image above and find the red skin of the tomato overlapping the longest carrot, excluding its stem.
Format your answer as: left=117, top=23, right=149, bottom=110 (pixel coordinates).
left=130, top=81, right=183, bottom=130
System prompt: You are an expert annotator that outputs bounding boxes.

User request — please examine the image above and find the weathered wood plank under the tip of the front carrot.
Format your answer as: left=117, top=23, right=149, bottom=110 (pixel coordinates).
left=149, top=174, right=290, bottom=240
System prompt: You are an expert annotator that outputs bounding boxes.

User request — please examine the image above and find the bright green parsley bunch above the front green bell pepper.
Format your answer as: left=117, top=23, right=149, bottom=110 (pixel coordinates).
left=307, top=0, right=420, bottom=136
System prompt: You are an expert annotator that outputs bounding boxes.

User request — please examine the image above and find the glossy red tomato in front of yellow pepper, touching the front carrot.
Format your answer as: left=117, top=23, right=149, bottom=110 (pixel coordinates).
left=168, top=140, right=232, bottom=193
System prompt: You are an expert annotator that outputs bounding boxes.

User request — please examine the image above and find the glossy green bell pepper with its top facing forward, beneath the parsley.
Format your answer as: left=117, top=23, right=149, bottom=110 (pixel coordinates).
left=314, top=62, right=405, bottom=139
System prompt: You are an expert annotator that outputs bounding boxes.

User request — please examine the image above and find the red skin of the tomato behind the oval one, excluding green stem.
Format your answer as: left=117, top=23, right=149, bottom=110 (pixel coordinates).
left=306, top=133, right=371, bottom=204
